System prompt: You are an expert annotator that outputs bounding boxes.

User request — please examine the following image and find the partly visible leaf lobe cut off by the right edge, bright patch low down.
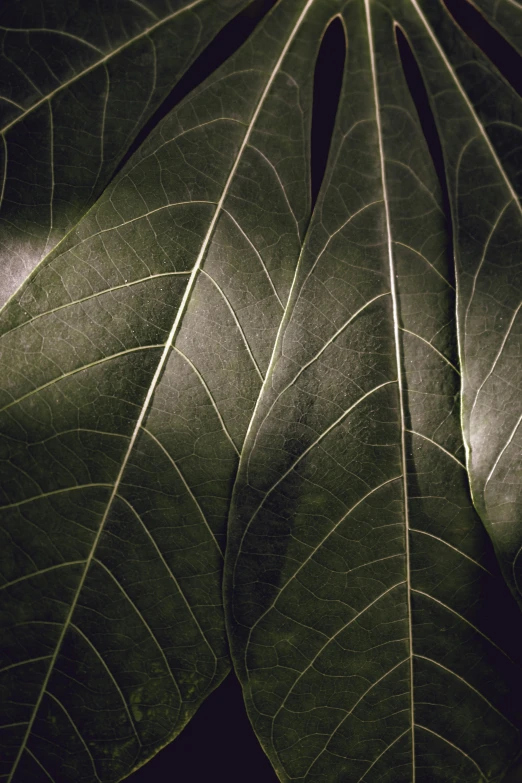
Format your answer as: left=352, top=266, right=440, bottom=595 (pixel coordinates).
left=406, top=0, right=522, bottom=601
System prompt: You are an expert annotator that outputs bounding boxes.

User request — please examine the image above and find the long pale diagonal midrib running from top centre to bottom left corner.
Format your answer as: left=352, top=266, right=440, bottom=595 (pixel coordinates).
left=4, top=0, right=314, bottom=783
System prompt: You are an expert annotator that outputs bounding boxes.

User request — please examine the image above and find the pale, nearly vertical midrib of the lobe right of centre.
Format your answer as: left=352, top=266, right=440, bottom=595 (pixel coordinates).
left=364, top=0, right=416, bottom=783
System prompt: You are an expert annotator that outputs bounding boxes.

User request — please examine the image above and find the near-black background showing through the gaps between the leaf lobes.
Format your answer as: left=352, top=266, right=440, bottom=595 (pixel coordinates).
left=120, top=0, right=522, bottom=783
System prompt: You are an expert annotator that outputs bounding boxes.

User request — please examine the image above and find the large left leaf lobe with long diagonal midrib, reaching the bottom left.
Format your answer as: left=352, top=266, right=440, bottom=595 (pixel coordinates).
left=0, top=0, right=319, bottom=783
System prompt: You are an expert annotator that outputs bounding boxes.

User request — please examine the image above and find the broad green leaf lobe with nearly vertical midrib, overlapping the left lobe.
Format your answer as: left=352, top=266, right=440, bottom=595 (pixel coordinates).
left=225, top=0, right=521, bottom=783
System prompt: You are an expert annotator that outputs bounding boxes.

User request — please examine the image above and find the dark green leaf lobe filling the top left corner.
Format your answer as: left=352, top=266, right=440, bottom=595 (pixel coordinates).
left=0, top=0, right=252, bottom=305
